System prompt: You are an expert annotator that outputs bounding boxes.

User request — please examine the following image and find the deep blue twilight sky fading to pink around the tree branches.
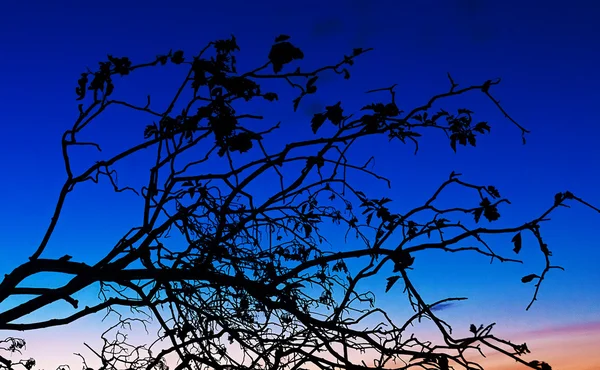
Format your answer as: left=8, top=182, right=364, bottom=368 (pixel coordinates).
left=0, top=0, right=600, bottom=370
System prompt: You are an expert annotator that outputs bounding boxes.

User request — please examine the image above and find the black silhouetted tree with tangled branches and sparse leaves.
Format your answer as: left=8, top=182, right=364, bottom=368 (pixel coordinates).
left=0, top=35, right=600, bottom=370
